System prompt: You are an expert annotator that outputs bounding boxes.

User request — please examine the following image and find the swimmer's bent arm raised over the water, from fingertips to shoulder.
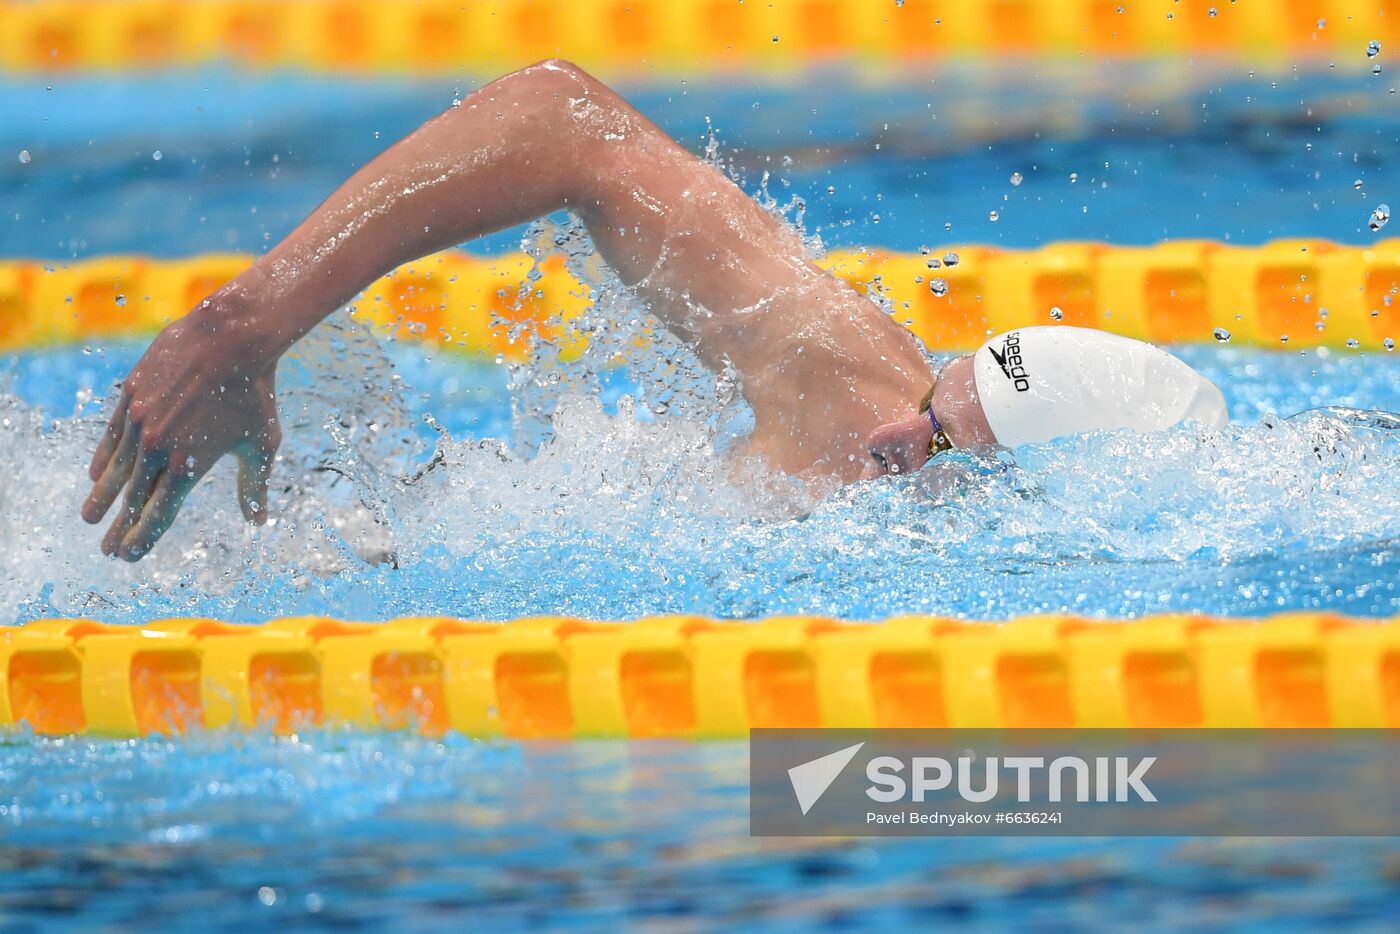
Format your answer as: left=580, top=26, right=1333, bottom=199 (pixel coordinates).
left=83, top=62, right=823, bottom=560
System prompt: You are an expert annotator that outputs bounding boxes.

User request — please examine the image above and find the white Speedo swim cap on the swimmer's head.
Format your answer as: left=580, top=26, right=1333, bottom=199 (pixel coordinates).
left=973, top=325, right=1229, bottom=448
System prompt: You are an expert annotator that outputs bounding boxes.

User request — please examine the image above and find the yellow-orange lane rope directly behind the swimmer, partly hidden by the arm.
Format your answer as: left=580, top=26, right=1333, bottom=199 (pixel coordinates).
left=0, top=239, right=1400, bottom=358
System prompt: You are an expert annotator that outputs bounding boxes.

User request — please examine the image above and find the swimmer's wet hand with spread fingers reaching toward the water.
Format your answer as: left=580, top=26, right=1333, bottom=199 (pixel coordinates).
left=83, top=295, right=281, bottom=562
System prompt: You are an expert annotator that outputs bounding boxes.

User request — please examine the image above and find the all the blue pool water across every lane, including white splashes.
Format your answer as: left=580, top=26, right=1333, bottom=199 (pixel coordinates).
left=0, top=67, right=1400, bottom=930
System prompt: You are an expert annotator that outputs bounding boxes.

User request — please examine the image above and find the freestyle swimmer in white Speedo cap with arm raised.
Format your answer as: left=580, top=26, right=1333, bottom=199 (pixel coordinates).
left=83, top=60, right=1225, bottom=562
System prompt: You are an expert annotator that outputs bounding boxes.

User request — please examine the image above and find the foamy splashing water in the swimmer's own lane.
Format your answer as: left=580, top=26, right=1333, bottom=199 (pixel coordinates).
left=0, top=225, right=1400, bottom=622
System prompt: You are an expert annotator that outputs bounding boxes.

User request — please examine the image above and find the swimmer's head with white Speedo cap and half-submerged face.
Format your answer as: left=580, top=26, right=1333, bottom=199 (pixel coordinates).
left=868, top=326, right=1228, bottom=473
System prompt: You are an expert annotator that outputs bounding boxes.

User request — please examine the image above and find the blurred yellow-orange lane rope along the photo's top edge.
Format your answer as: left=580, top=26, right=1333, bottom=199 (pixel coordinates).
left=0, top=0, right=1389, bottom=74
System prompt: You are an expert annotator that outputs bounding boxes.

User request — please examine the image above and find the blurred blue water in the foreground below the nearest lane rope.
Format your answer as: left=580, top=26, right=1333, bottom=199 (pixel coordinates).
left=0, top=734, right=1400, bottom=931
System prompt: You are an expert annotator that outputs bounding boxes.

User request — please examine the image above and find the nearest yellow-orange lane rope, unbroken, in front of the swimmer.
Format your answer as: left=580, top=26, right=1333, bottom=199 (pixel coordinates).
left=0, top=613, right=1400, bottom=738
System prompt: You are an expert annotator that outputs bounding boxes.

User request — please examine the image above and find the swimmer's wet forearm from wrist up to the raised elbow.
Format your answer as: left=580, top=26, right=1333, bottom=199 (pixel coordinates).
left=208, top=63, right=618, bottom=357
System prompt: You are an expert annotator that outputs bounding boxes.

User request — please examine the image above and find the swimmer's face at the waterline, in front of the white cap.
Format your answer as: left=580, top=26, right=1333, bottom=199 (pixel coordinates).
left=865, top=354, right=997, bottom=476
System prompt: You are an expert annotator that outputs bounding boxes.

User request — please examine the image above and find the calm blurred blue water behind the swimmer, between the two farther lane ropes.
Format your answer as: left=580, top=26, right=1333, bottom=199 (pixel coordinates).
left=8, top=64, right=1400, bottom=260
